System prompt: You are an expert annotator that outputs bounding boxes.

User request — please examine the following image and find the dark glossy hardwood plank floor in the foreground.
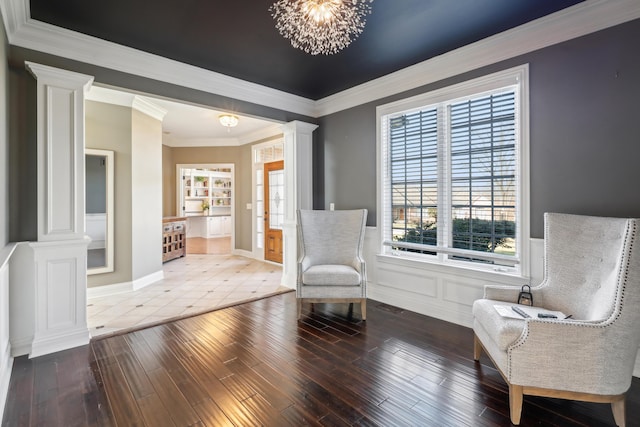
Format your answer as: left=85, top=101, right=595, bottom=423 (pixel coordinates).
left=3, top=293, right=640, bottom=427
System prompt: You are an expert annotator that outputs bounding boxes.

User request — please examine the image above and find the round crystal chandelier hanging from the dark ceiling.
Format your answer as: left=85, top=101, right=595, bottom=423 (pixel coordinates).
left=269, top=0, right=373, bottom=55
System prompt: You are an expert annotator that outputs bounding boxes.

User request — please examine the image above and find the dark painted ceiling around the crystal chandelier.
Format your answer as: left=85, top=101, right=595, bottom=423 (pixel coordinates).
left=30, top=0, right=583, bottom=99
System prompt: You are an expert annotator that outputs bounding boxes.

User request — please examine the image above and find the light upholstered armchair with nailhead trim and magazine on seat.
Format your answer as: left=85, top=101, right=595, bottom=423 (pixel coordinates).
left=473, top=214, right=640, bottom=426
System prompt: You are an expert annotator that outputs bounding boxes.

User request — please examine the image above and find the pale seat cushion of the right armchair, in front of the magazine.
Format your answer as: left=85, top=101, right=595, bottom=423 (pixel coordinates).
left=472, top=299, right=525, bottom=351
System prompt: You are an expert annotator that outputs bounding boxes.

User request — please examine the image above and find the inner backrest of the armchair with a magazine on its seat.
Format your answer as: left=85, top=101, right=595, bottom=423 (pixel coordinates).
left=536, top=213, right=629, bottom=320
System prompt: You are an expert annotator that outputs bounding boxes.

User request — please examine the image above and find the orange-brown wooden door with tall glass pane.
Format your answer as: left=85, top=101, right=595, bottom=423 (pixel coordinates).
left=264, top=160, right=285, bottom=264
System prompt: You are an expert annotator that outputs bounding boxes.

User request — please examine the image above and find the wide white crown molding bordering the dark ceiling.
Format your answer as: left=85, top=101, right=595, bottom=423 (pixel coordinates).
left=0, top=0, right=640, bottom=117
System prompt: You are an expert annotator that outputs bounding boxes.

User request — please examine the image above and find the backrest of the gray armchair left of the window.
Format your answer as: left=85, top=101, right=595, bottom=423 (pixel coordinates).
left=298, top=209, right=367, bottom=268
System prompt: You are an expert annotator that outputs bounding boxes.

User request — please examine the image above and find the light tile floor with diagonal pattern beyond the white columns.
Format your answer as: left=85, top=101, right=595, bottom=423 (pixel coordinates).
left=87, top=255, right=287, bottom=337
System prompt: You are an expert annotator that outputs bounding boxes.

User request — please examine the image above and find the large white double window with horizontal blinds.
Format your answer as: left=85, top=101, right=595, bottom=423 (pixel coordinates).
left=378, top=66, right=529, bottom=274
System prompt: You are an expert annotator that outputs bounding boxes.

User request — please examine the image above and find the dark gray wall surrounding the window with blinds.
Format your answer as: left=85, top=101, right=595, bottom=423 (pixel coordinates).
left=315, top=20, right=640, bottom=238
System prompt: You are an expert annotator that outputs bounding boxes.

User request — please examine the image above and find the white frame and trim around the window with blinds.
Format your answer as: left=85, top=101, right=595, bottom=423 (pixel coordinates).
left=376, top=64, right=530, bottom=277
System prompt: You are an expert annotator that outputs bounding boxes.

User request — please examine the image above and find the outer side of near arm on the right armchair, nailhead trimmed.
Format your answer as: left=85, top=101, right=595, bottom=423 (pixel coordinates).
left=505, top=319, right=638, bottom=395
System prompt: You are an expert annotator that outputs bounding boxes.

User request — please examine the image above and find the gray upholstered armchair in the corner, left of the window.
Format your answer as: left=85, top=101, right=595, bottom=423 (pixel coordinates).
left=296, top=209, right=367, bottom=320
